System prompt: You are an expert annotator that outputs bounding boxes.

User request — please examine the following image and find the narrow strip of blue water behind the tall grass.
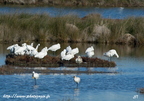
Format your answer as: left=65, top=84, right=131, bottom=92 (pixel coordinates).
left=0, top=6, right=144, bottom=19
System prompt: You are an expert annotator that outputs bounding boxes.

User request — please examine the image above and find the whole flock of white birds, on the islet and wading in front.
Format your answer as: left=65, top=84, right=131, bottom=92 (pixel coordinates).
left=7, top=43, right=119, bottom=87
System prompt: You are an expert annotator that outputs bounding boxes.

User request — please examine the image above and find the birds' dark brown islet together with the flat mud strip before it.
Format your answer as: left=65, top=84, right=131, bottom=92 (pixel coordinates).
left=0, top=54, right=118, bottom=75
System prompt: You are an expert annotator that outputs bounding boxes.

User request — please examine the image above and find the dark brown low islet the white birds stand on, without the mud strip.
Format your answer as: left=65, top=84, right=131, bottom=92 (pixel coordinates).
left=5, top=54, right=116, bottom=67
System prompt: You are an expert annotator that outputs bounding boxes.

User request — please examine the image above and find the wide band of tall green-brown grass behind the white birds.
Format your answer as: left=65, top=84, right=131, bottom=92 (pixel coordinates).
left=0, top=14, right=144, bottom=43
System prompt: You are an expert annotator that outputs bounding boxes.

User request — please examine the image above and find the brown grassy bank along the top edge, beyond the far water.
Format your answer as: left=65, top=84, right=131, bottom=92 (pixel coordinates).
left=0, top=0, right=144, bottom=7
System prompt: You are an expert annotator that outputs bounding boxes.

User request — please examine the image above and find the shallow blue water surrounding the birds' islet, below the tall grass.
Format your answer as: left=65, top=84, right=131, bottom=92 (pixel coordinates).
left=0, top=44, right=144, bottom=101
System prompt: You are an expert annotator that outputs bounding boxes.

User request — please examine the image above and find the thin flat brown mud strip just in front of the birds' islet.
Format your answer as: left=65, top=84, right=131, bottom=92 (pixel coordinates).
left=0, top=65, right=118, bottom=75
